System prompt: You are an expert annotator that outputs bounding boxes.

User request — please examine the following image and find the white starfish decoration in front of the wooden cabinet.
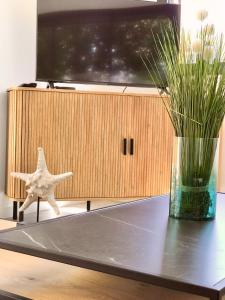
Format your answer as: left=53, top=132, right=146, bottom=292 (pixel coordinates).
left=11, top=147, right=73, bottom=215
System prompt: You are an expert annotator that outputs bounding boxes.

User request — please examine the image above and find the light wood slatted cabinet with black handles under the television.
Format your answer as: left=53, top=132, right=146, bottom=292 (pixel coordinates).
left=6, top=88, right=173, bottom=199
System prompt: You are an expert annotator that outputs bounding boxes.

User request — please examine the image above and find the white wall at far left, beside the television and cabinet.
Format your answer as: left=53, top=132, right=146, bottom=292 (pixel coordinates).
left=0, top=0, right=36, bottom=210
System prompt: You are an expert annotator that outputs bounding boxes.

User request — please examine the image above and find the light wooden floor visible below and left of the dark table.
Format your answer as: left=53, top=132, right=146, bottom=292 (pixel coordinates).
left=0, top=220, right=206, bottom=300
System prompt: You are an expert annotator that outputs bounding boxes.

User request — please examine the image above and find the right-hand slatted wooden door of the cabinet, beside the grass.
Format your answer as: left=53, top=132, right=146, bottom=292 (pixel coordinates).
left=125, top=96, right=173, bottom=196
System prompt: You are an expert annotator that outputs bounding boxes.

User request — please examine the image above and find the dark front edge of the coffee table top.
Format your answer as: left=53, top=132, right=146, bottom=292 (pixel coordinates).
left=0, top=239, right=220, bottom=299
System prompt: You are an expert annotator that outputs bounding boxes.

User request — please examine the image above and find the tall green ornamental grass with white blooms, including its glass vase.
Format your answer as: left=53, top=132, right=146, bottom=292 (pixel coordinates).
left=142, top=11, right=225, bottom=220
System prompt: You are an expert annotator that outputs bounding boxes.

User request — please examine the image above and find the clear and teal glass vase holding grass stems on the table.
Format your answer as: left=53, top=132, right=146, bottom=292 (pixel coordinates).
left=169, top=137, right=219, bottom=220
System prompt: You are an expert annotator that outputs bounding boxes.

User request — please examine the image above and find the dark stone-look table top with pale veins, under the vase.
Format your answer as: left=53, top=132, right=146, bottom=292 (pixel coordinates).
left=0, top=194, right=225, bottom=299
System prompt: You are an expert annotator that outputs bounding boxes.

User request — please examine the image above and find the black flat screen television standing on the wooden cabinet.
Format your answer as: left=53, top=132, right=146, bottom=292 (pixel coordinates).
left=36, top=0, right=180, bottom=87
